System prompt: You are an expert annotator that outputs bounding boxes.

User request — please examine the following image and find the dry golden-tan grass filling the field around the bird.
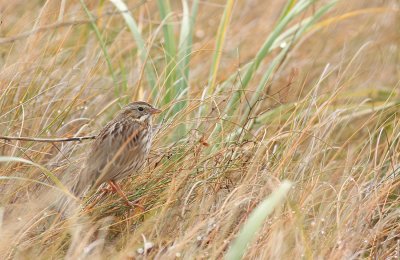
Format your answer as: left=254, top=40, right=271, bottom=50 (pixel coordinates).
left=0, top=0, right=400, bottom=259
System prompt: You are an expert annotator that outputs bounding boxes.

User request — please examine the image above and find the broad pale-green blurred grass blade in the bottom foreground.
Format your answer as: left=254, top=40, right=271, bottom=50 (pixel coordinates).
left=225, top=181, right=292, bottom=260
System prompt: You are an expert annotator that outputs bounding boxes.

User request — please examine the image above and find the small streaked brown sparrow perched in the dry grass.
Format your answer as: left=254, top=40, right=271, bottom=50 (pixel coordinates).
left=72, top=101, right=162, bottom=205
